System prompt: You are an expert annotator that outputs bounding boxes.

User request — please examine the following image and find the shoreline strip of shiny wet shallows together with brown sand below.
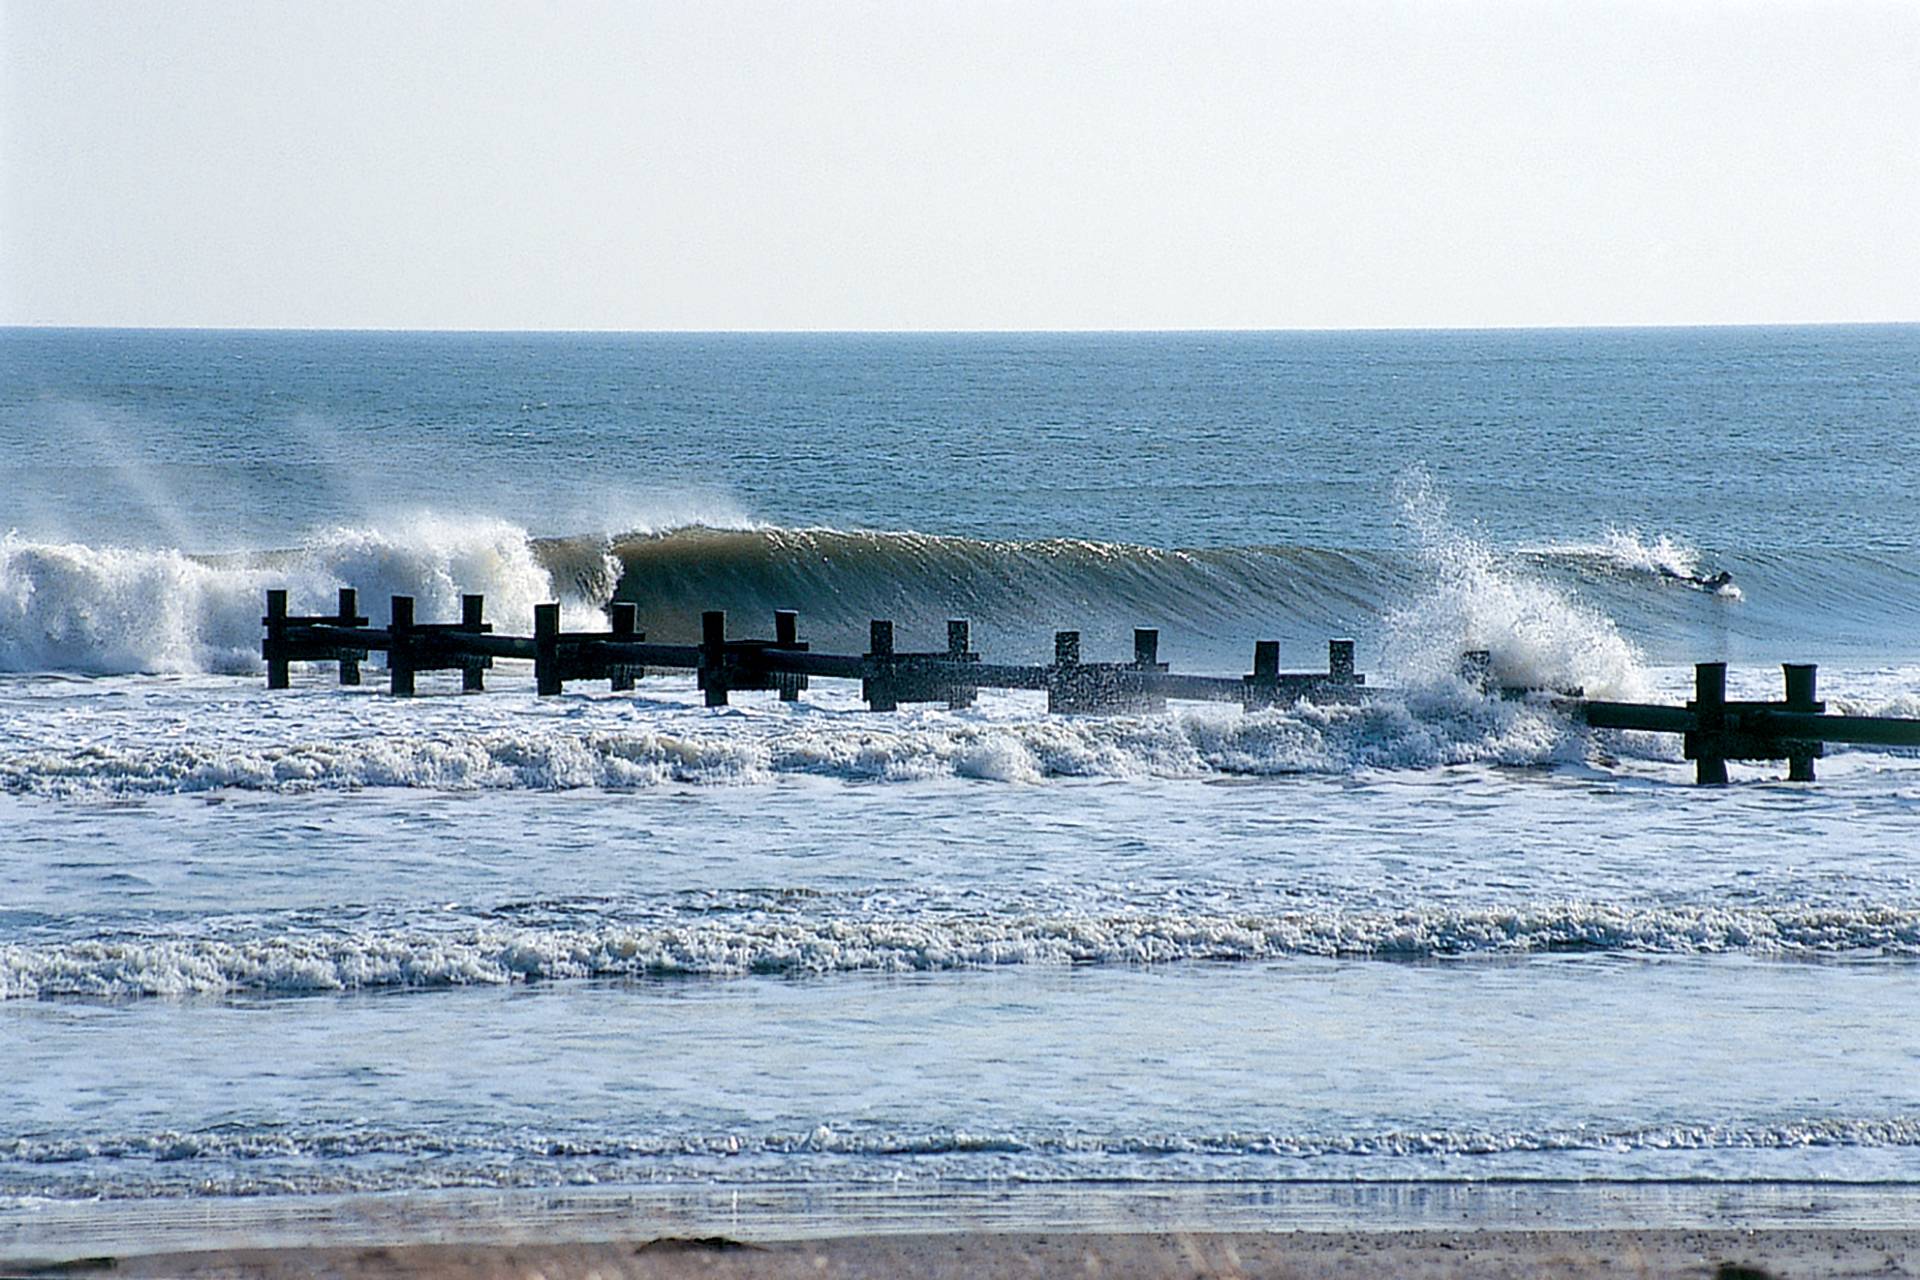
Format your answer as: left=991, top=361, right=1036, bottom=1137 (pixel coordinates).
left=11, top=1180, right=1920, bottom=1280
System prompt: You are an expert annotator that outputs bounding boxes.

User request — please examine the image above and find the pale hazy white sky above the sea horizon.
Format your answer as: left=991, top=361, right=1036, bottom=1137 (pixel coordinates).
left=0, top=0, right=1920, bottom=330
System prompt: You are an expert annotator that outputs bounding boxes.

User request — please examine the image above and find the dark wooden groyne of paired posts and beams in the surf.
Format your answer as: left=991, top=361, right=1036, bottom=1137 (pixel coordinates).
left=261, top=587, right=1920, bottom=785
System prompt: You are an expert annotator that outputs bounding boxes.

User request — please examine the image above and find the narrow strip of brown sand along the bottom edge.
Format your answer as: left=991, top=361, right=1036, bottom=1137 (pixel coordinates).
left=26, top=1228, right=1920, bottom=1280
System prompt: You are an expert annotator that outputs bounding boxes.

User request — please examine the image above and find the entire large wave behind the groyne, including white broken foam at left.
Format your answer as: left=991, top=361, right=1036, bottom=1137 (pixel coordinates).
left=0, top=502, right=1920, bottom=697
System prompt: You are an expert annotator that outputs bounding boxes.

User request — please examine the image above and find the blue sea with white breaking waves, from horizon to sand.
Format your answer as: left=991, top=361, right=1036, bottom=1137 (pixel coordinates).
left=0, top=326, right=1920, bottom=1247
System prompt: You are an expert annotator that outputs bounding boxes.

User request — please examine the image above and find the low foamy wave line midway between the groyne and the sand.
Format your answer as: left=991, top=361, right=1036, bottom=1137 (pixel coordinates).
left=0, top=902, right=1920, bottom=1000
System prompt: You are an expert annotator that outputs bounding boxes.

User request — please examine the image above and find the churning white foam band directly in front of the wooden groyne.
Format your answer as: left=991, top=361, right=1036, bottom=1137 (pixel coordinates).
left=0, top=694, right=1620, bottom=798
